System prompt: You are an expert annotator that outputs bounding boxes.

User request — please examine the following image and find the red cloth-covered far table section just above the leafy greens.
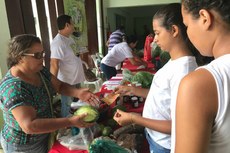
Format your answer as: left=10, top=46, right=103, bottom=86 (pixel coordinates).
left=121, top=59, right=156, bottom=73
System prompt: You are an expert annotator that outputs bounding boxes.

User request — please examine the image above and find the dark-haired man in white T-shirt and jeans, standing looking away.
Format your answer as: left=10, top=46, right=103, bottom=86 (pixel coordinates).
left=50, top=15, right=85, bottom=117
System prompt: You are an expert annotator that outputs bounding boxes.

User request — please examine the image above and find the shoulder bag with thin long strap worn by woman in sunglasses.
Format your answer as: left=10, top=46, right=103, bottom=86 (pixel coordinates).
left=39, top=72, right=57, bottom=150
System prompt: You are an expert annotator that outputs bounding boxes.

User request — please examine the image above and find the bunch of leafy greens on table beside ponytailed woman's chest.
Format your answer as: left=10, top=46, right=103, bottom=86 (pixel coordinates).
left=131, top=71, right=153, bottom=88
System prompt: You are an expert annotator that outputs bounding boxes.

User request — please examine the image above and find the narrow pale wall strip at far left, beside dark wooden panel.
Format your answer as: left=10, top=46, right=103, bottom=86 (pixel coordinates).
left=0, top=1, right=10, bottom=80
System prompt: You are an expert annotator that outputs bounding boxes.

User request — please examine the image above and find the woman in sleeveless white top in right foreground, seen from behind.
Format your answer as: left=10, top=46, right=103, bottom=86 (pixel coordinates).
left=172, top=0, right=230, bottom=153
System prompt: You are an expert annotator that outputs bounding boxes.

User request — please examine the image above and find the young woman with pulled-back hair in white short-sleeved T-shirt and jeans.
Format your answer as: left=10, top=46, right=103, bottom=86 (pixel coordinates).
left=114, top=3, right=197, bottom=153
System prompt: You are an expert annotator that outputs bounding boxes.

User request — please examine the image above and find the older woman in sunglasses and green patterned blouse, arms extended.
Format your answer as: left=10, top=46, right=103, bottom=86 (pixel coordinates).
left=0, top=34, right=97, bottom=153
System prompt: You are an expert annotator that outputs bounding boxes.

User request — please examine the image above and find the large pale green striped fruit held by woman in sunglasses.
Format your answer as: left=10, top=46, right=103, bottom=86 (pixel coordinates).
left=74, top=106, right=99, bottom=123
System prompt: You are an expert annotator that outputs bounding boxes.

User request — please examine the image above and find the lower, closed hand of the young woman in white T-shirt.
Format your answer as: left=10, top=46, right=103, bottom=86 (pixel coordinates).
left=113, top=109, right=137, bottom=126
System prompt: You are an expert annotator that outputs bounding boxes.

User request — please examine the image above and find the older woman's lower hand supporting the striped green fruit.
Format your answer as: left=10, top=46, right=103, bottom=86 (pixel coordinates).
left=69, top=113, right=95, bottom=128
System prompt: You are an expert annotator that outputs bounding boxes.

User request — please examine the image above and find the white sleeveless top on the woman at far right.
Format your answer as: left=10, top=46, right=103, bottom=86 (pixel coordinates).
left=202, top=54, right=230, bottom=153
